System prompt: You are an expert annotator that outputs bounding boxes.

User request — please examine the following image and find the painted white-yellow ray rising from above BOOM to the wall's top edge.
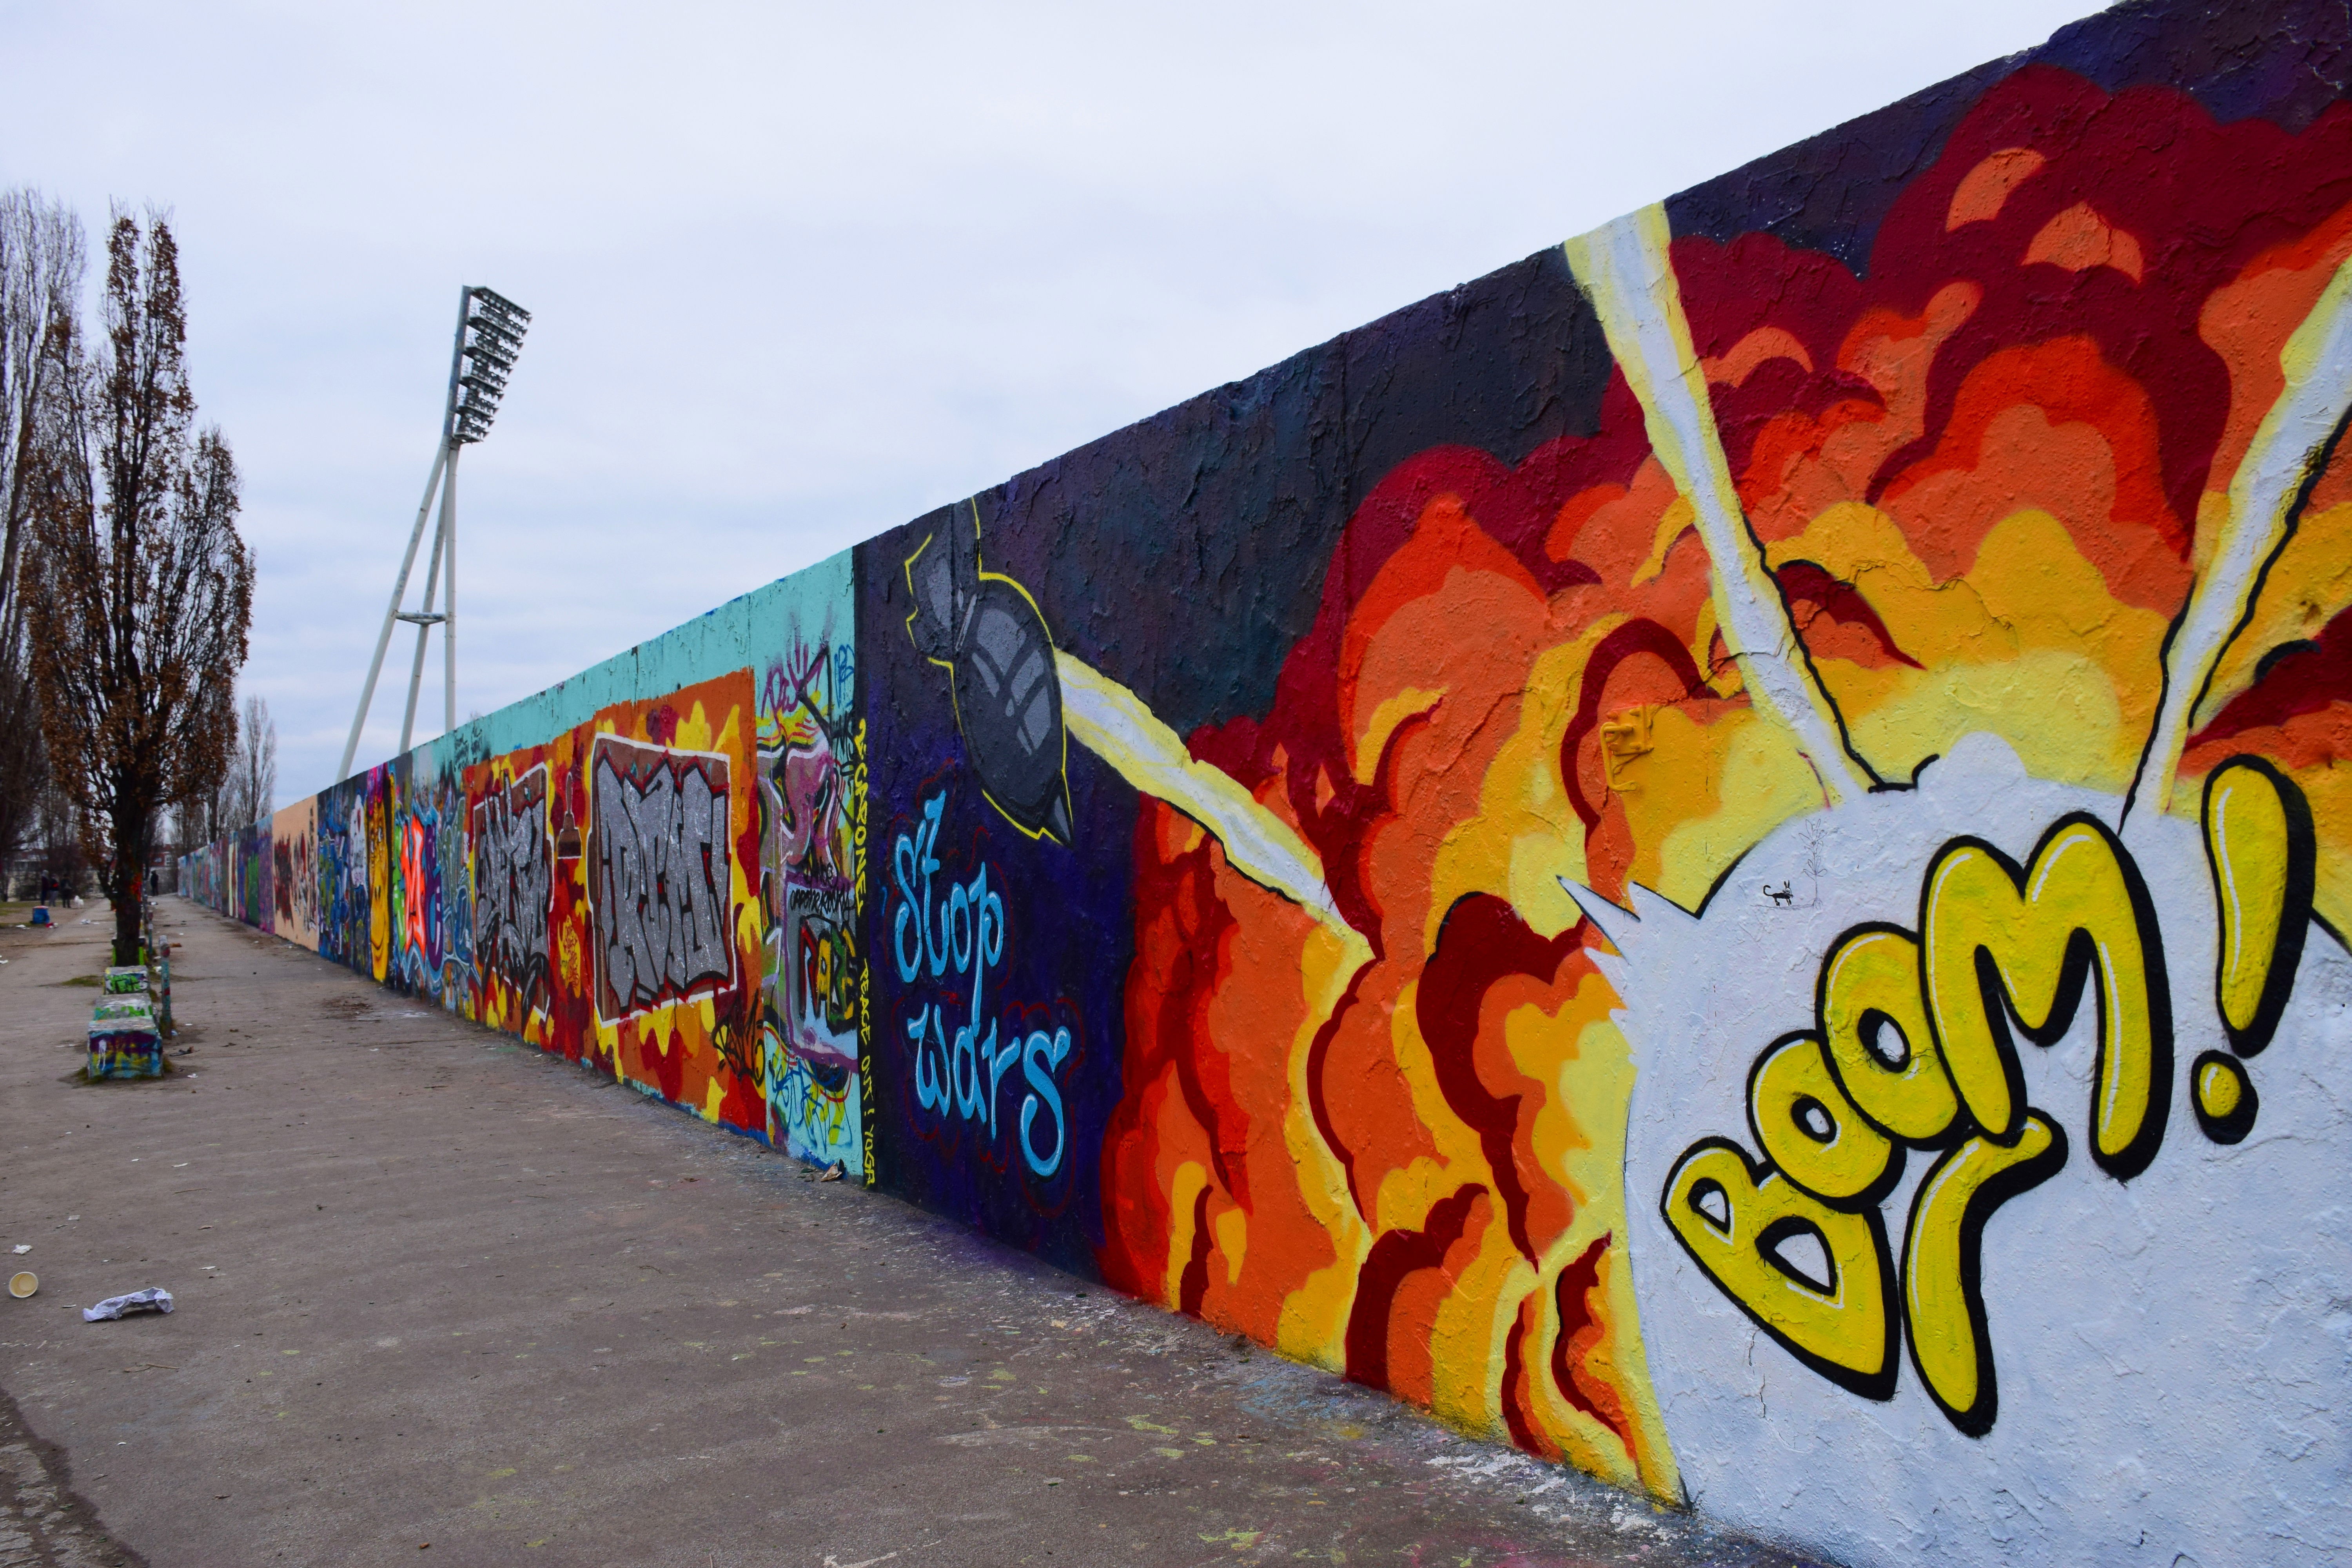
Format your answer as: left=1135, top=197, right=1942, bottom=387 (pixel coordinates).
left=1564, top=207, right=1877, bottom=804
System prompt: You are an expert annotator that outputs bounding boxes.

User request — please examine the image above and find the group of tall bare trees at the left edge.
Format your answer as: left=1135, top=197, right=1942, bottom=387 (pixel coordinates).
left=0, top=191, right=260, bottom=964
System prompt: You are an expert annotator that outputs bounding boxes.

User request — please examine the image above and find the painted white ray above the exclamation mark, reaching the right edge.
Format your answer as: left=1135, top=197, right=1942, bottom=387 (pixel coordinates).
left=2124, top=261, right=2352, bottom=813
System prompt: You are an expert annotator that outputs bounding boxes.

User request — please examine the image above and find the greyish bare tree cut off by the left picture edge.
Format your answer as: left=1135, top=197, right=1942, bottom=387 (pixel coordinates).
left=0, top=191, right=82, bottom=858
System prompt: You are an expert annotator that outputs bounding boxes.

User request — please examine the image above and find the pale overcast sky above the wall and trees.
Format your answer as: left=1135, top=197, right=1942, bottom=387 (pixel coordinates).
left=0, top=0, right=2096, bottom=799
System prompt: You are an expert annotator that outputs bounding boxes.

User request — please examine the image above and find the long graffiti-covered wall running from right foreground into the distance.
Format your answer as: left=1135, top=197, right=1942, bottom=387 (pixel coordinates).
left=188, top=0, right=2352, bottom=1563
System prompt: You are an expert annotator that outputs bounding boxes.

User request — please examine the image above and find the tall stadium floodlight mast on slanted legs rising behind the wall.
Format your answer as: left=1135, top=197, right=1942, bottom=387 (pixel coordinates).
left=336, top=285, right=532, bottom=778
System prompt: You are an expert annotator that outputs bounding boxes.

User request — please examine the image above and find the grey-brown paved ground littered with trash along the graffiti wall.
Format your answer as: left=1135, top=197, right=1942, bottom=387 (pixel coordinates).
left=0, top=898, right=1795, bottom=1568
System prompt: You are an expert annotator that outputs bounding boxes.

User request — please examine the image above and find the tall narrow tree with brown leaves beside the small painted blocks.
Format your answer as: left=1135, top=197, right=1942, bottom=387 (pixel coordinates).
left=26, top=212, right=254, bottom=964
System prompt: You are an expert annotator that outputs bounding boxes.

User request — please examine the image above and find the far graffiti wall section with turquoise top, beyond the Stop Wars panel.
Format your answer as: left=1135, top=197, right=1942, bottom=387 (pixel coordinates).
left=188, top=555, right=866, bottom=1152
